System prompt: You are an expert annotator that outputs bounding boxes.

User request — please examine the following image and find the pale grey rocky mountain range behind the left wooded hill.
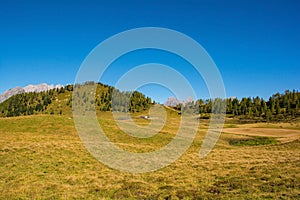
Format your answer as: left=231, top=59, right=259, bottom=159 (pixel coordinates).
left=0, top=83, right=63, bottom=103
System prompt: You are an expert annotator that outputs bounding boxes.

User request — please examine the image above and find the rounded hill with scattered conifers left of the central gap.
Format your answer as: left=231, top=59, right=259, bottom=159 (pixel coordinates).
left=0, top=82, right=152, bottom=117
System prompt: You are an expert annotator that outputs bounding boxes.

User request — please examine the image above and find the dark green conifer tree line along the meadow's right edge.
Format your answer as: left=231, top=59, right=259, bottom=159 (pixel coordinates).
left=174, top=90, right=300, bottom=121
